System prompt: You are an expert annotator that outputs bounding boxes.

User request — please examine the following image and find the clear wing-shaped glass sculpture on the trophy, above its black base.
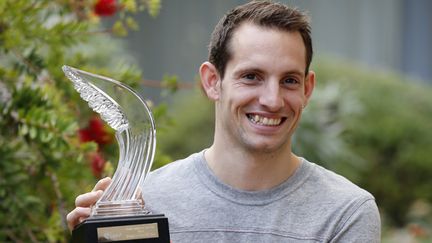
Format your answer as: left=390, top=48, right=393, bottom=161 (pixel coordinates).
left=63, top=66, right=156, bottom=217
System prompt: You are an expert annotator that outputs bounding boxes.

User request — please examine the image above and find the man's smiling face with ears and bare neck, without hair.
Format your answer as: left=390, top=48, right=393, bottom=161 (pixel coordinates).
left=200, top=19, right=315, bottom=191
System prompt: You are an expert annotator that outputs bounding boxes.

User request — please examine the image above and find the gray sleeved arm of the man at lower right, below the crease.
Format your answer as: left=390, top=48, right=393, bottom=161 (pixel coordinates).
left=330, top=199, right=381, bottom=243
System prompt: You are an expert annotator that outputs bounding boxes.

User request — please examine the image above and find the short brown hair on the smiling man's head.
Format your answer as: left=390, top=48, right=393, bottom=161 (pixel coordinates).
left=209, top=1, right=313, bottom=78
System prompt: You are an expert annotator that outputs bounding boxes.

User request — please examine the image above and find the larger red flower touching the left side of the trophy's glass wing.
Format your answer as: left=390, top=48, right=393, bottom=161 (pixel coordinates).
left=79, top=116, right=113, bottom=145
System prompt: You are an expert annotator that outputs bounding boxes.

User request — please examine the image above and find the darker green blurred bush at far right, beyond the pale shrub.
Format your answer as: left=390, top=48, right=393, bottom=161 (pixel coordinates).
left=317, top=58, right=432, bottom=226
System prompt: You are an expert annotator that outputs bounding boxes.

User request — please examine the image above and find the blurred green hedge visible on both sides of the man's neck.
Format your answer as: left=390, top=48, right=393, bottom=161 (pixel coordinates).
left=159, top=59, right=432, bottom=230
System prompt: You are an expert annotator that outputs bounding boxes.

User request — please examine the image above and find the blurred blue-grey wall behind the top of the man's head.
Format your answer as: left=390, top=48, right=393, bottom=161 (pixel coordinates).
left=127, top=0, right=432, bottom=87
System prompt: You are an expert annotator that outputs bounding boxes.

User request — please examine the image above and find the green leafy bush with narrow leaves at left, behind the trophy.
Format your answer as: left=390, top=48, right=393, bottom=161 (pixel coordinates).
left=0, top=0, right=159, bottom=242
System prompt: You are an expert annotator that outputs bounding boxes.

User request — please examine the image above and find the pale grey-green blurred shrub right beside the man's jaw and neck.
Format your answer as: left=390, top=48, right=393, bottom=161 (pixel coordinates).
left=293, top=81, right=365, bottom=179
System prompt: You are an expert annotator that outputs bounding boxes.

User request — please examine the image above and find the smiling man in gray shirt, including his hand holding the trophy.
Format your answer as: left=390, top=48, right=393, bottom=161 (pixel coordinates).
left=68, top=1, right=380, bottom=242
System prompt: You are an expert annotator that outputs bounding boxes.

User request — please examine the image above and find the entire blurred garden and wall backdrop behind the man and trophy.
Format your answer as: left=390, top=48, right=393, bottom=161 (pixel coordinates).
left=0, top=0, right=432, bottom=242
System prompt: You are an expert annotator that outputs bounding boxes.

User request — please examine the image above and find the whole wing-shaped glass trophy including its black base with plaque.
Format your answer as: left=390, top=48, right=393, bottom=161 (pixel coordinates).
left=62, top=66, right=170, bottom=242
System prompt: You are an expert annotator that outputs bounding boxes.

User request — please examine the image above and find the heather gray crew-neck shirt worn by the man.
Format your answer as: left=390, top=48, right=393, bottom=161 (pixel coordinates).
left=143, top=152, right=381, bottom=243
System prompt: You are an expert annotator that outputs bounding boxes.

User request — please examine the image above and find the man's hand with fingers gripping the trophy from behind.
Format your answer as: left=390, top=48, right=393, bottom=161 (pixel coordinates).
left=66, top=177, right=111, bottom=230
